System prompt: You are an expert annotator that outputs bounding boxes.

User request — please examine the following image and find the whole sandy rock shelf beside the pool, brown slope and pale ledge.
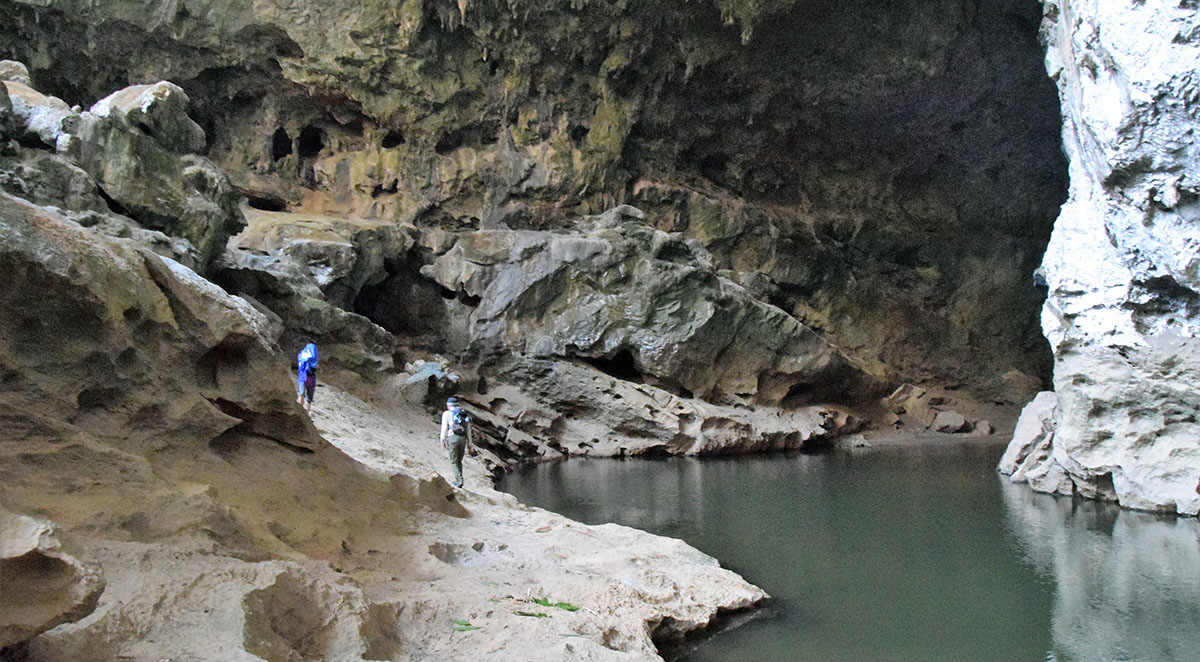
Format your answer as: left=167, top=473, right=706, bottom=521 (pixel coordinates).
left=7, top=384, right=767, bottom=662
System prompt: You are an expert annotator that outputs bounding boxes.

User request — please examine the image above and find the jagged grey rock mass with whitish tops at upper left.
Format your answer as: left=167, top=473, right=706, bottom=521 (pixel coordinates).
left=0, top=75, right=245, bottom=271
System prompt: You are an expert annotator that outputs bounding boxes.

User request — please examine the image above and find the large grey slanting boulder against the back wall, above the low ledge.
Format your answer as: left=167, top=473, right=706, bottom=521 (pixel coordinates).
left=421, top=207, right=874, bottom=404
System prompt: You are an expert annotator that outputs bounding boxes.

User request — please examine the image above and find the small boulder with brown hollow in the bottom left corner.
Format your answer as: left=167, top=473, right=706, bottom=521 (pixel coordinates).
left=0, top=511, right=104, bottom=649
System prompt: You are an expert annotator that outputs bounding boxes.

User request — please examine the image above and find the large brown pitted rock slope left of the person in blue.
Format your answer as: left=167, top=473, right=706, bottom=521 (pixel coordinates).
left=0, top=193, right=320, bottom=447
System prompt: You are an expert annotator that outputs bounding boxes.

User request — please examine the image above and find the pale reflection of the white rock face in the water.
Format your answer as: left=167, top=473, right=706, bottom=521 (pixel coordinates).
left=1002, top=481, right=1200, bottom=662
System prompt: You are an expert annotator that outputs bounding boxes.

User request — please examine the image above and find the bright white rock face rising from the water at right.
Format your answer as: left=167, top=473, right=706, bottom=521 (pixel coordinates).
left=1013, top=0, right=1200, bottom=514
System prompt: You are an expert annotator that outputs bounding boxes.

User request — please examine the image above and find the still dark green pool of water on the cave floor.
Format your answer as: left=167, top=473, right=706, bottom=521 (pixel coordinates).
left=502, top=444, right=1200, bottom=662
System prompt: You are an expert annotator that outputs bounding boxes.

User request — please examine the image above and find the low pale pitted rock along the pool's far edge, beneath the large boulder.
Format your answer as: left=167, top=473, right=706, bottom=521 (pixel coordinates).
left=466, top=356, right=863, bottom=458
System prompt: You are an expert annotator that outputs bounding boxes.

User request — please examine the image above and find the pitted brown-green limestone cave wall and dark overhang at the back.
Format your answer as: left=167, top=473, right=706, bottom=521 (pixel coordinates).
left=0, top=0, right=1064, bottom=402
